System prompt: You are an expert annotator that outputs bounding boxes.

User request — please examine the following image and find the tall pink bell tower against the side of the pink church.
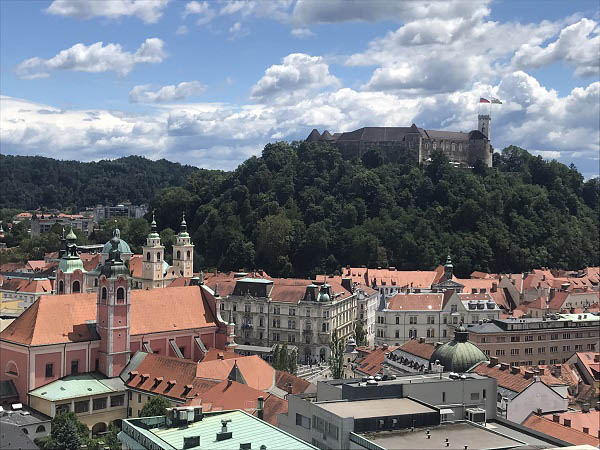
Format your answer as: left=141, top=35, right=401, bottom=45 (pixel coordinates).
left=96, top=236, right=131, bottom=377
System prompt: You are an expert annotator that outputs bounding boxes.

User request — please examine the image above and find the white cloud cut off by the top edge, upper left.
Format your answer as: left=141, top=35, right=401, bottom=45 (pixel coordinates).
left=46, top=0, right=169, bottom=23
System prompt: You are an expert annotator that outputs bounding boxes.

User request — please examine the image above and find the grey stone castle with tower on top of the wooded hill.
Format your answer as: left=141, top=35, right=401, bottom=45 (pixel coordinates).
left=306, top=114, right=493, bottom=167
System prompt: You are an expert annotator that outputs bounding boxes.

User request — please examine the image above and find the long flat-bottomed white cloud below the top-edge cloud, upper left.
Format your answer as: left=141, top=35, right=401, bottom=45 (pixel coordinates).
left=17, top=38, right=166, bottom=79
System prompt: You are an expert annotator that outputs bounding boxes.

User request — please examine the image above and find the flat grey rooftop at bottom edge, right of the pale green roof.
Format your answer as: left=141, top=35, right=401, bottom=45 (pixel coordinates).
left=359, top=422, right=524, bottom=450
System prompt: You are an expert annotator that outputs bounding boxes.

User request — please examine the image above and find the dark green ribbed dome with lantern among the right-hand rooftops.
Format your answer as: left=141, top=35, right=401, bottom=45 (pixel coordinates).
left=429, top=325, right=487, bottom=373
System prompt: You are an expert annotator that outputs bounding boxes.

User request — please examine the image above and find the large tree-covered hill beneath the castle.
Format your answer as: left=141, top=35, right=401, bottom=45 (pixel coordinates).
left=152, top=142, right=600, bottom=277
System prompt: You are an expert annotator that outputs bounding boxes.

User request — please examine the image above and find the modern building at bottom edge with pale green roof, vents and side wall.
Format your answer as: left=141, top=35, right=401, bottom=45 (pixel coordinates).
left=118, top=407, right=316, bottom=450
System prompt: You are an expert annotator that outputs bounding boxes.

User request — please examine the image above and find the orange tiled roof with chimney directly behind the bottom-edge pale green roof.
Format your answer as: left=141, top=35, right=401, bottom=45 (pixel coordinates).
left=187, top=380, right=288, bottom=425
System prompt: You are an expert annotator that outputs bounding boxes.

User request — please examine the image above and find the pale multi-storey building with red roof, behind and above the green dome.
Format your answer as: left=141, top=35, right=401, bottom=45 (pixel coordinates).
left=375, top=291, right=501, bottom=345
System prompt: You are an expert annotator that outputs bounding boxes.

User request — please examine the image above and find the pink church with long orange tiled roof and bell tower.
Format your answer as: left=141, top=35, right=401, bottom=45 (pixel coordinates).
left=0, top=236, right=235, bottom=404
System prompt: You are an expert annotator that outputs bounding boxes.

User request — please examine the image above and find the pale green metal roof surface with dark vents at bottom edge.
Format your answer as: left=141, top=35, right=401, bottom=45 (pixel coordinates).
left=119, top=410, right=316, bottom=450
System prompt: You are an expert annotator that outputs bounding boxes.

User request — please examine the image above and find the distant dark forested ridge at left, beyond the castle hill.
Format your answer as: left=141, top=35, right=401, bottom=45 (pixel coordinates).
left=0, top=155, right=198, bottom=210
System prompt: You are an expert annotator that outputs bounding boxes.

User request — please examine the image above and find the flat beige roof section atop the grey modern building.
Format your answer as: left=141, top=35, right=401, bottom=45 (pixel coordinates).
left=316, top=398, right=437, bottom=418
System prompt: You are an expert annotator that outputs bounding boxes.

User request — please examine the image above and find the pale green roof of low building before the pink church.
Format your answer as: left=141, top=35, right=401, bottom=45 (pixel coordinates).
left=29, top=373, right=125, bottom=402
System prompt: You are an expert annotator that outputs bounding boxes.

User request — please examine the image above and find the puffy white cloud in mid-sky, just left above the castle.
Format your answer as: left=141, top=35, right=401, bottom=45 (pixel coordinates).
left=251, top=53, right=340, bottom=102
